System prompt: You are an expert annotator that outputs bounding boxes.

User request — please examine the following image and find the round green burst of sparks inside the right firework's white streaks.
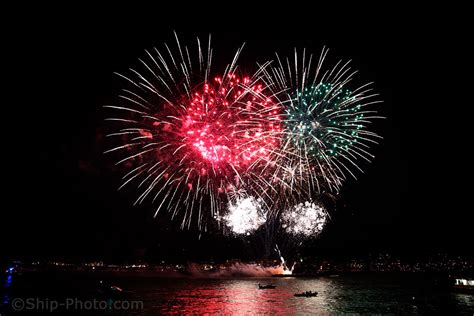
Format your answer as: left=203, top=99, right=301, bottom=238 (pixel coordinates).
left=286, top=83, right=364, bottom=159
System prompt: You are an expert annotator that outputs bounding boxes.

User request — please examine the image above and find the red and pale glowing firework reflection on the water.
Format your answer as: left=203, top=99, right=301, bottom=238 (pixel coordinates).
left=138, top=277, right=344, bottom=314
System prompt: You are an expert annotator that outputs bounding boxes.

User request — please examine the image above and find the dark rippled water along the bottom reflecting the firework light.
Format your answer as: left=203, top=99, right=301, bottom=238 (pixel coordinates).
left=0, top=273, right=474, bottom=316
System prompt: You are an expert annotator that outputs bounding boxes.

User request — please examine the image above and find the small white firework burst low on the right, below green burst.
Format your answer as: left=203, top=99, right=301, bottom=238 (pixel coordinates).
left=281, top=201, right=328, bottom=238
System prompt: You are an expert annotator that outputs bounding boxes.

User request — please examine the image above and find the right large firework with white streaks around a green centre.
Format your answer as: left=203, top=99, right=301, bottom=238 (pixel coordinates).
left=256, top=49, right=381, bottom=196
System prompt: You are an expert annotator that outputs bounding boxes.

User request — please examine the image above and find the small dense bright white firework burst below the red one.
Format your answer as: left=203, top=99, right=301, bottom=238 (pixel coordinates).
left=224, top=197, right=267, bottom=235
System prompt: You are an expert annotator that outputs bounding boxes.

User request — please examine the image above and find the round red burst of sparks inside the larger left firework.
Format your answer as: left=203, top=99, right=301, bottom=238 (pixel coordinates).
left=182, top=75, right=281, bottom=169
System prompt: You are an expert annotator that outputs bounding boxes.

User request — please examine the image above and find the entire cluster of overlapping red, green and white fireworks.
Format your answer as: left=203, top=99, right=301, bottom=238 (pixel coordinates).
left=106, top=34, right=380, bottom=235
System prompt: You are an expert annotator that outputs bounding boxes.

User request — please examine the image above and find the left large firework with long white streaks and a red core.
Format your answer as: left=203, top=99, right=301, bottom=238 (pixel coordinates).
left=106, top=34, right=282, bottom=229
